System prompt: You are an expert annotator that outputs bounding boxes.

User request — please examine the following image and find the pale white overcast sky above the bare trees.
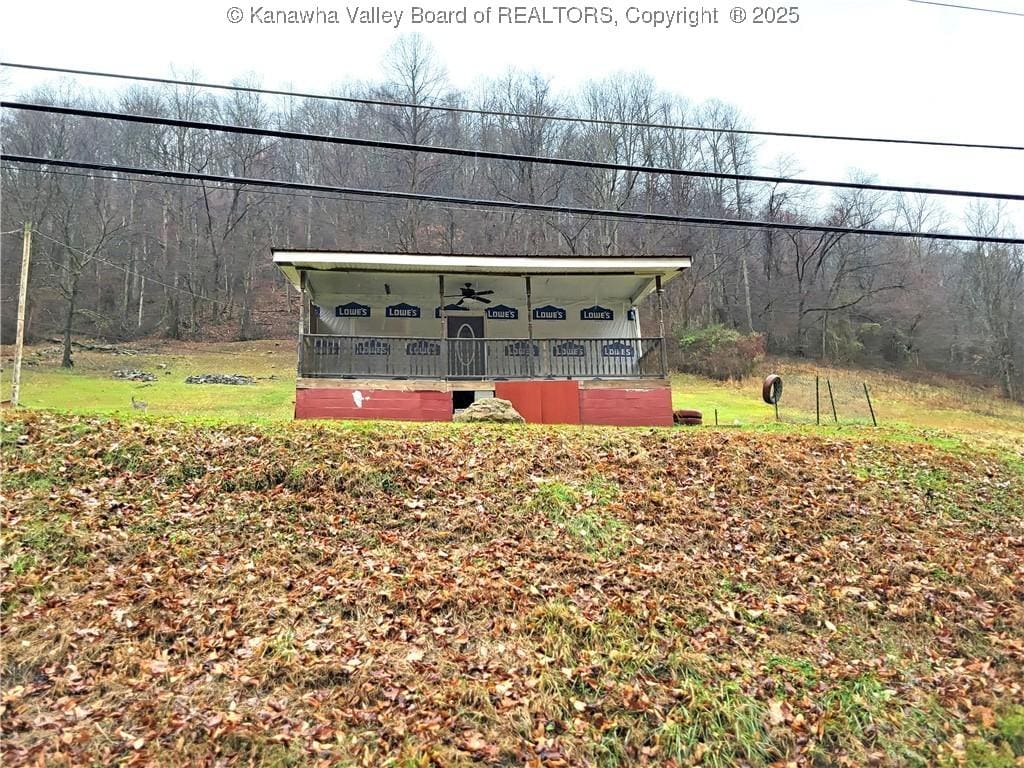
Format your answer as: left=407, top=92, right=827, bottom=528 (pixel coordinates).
left=0, top=0, right=1024, bottom=236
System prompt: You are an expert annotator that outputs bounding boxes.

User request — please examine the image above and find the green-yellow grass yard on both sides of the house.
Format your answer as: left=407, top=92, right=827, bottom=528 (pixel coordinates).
left=8, top=341, right=1024, bottom=443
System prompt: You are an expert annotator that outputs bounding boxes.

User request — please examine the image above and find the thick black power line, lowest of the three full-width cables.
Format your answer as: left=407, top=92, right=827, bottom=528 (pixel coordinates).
left=0, top=153, right=1024, bottom=245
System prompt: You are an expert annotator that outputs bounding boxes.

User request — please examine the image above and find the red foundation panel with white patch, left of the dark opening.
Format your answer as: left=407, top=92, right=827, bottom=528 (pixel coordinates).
left=295, top=387, right=453, bottom=421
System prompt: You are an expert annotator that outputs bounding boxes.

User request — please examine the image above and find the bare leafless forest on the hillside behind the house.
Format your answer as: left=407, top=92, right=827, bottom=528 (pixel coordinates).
left=0, top=36, right=1024, bottom=399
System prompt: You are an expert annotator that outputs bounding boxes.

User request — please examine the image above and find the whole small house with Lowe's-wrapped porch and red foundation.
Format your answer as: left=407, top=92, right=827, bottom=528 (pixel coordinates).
left=273, top=250, right=690, bottom=425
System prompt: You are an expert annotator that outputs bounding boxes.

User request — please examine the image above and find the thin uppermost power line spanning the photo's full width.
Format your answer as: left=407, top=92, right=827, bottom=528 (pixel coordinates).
left=0, top=61, right=1024, bottom=152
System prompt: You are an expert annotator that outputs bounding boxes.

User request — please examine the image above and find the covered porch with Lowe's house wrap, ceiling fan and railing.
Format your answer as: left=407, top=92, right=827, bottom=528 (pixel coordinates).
left=274, top=251, right=689, bottom=381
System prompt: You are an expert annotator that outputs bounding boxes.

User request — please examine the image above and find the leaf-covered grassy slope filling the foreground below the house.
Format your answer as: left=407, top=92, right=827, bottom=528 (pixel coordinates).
left=0, top=413, right=1024, bottom=766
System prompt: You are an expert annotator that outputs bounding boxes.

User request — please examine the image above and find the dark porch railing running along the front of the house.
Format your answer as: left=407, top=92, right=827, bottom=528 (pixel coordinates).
left=299, top=334, right=666, bottom=380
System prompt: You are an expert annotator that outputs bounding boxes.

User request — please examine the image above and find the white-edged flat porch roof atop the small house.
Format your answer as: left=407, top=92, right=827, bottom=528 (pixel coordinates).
left=272, top=249, right=690, bottom=287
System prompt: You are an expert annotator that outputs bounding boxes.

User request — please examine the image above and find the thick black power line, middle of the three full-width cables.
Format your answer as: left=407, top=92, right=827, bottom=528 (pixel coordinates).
left=0, top=101, right=1024, bottom=201
